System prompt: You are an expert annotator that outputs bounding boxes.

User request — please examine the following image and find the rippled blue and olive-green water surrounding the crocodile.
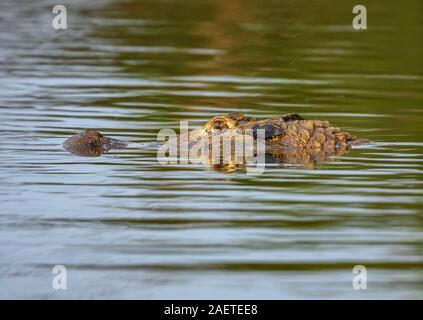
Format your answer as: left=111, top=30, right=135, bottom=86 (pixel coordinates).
left=0, top=0, right=423, bottom=298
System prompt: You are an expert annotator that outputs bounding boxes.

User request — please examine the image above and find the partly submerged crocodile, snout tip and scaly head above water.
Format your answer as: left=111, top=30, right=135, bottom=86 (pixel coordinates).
left=64, top=112, right=369, bottom=171
